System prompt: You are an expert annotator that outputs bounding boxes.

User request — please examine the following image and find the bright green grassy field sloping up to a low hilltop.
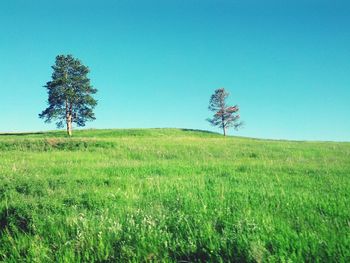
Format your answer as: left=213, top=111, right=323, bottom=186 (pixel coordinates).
left=0, top=129, right=350, bottom=262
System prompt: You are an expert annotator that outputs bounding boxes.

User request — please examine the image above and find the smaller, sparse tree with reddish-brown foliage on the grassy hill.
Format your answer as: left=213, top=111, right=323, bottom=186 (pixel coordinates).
left=207, top=88, right=243, bottom=136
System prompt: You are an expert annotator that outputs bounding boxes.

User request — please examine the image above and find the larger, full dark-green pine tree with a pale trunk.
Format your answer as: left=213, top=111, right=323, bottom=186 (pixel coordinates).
left=39, top=55, right=97, bottom=136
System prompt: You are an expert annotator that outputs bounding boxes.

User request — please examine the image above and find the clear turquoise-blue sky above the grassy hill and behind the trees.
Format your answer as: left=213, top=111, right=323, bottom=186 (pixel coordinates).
left=0, top=0, right=350, bottom=141
